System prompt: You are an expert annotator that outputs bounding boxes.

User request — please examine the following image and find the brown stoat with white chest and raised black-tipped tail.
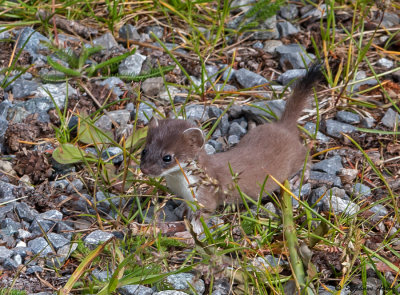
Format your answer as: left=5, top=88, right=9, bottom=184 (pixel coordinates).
left=140, top=65, right=323, bottom=229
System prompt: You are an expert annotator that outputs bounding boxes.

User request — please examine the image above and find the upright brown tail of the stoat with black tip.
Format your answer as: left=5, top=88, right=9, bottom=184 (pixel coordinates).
left=279, top=64, right=324, bottom=127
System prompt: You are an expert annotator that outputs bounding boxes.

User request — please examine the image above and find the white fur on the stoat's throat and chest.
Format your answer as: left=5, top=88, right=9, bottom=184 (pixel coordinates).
left=164, top=171, right=198, bottom=201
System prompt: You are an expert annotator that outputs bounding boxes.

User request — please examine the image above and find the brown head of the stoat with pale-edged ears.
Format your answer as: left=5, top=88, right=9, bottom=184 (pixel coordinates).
left=140, top=118, right=204, bottom=176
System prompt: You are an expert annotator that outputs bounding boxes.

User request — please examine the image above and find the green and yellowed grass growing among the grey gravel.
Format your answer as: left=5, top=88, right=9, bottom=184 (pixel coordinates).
left=0, top=0, right=400, bottom=294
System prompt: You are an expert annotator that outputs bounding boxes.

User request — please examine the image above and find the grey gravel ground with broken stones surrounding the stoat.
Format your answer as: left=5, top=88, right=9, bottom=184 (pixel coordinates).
left=0, top=2, right=400, bottom=295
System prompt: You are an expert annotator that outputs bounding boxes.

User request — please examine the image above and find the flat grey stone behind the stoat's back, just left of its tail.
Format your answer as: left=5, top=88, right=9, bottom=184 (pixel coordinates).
left=242, top=99, right=286, bottom=124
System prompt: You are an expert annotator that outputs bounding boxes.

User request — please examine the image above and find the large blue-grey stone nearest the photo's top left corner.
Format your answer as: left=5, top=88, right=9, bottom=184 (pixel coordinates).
left=16, top=27, right=50, bottom=63
